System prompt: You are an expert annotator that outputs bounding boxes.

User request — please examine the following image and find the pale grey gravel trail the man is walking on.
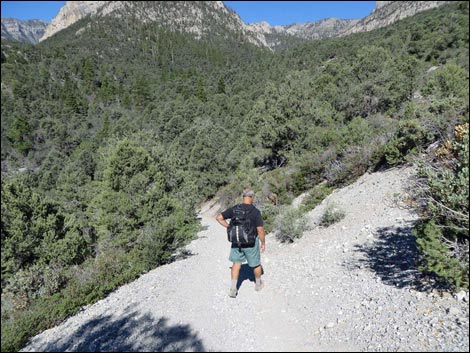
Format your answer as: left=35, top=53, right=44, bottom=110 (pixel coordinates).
left=23, top=168, right=469, bottom=352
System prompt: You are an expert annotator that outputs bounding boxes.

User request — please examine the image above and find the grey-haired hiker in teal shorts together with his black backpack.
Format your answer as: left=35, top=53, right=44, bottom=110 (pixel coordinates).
left=216, top=189, right=266, bottom=298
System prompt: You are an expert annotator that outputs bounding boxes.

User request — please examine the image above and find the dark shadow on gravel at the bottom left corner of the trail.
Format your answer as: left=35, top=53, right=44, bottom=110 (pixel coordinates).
left=28, top=304, right=205, bottom=352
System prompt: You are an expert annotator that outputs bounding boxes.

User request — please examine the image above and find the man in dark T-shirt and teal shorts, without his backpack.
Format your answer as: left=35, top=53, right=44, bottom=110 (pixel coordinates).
left=216, top=189, right=266, bottom=298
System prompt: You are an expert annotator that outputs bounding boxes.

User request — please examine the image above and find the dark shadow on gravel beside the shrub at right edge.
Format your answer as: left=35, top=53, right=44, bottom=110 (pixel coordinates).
left=348, top=224, right=446, bottom=292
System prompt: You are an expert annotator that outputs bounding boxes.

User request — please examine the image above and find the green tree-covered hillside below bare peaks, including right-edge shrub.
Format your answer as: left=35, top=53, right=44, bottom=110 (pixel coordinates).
left=1, top=2, right=469, bottom=351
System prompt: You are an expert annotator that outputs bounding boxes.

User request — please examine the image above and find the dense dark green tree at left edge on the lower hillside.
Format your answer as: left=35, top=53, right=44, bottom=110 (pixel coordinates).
left=1, top=178, right=90, bottom=287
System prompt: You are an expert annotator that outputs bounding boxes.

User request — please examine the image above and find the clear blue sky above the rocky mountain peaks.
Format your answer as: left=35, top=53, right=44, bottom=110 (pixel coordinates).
left=1, top=1, right=375, bottom=26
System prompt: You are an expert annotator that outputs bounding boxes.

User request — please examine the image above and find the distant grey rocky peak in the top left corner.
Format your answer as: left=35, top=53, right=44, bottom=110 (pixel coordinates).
left=2, top=18, right=48, bottom=44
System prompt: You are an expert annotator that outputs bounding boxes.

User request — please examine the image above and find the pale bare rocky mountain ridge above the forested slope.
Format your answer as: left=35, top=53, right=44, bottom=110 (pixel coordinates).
left=2, top=1, right=456, bottom=50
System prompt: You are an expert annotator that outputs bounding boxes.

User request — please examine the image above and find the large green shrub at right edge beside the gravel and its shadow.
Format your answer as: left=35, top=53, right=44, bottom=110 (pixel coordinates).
left=413, top=123, right=469, bottom=288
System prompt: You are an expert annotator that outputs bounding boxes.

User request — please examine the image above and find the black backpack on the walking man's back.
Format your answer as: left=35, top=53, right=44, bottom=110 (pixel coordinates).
left=227, top=205, right=258, bottom=247
